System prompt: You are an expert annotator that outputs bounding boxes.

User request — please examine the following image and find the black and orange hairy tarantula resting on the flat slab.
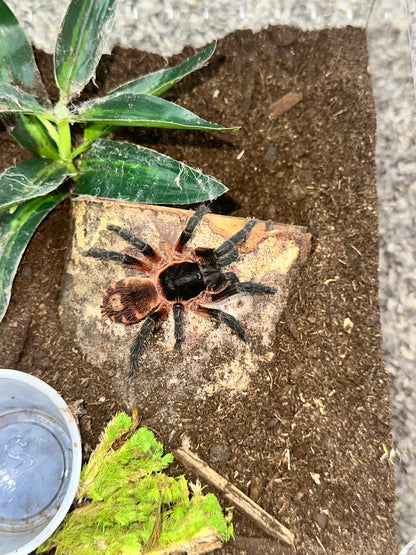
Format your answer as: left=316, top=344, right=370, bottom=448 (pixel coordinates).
left=83, top=206, right=276, bottom=377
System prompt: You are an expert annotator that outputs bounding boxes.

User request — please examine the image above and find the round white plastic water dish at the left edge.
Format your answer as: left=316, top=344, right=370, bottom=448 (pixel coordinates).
left=0, top=369, right=81, bottom=555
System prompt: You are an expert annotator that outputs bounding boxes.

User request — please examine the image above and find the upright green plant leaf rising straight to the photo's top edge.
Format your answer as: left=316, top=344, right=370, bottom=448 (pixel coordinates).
left=54, top=0, right=118, bottom=104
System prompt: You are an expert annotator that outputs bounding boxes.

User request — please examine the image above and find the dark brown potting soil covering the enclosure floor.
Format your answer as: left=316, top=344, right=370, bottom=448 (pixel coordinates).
left=0, top=27, right=396, bottom=554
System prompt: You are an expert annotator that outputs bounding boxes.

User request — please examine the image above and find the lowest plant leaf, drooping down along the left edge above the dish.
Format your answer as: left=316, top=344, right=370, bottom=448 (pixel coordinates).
left=0, top=192, right=68, bottom=321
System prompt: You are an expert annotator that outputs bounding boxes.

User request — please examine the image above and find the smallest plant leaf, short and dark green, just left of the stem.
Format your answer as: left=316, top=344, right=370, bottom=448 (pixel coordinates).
left=12, top=115, right=59, bottom=160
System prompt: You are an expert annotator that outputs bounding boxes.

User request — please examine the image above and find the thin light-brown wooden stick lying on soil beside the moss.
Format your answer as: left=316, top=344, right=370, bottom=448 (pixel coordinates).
left=173, top=447, right=295, bottom=545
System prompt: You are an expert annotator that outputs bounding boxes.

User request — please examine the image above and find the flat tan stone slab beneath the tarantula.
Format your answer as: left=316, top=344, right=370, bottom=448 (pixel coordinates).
left=61, top=199, right=310, bottom=404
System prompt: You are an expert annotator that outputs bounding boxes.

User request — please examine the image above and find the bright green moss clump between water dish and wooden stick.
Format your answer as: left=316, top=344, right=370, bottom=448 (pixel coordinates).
left=38, top=413, right=232, bottom=555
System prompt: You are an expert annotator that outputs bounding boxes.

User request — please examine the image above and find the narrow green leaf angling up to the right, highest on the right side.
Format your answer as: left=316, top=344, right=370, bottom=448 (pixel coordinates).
left=107, top=42, right=217, bottom=97
